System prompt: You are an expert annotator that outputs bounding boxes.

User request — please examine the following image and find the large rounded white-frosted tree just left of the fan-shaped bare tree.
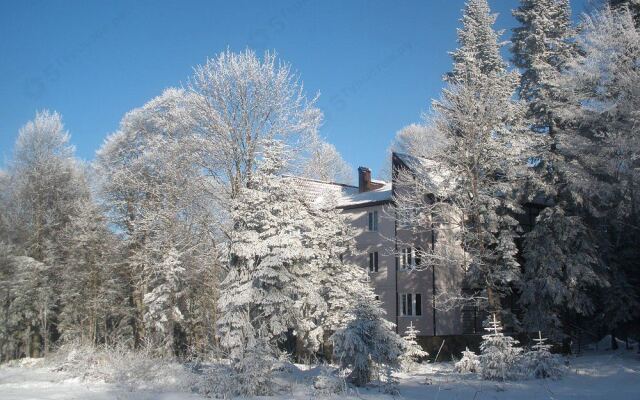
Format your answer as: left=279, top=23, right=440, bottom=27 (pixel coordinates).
left=96, top=89, right=226, bottom=350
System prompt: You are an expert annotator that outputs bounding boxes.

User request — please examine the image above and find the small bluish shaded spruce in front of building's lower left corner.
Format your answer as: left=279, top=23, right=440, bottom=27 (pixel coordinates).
left=331, top=289, right=406, bottom=386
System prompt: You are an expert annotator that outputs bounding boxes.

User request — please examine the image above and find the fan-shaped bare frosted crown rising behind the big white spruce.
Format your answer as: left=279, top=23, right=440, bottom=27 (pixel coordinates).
left=188, top=50, right=322, bottom=197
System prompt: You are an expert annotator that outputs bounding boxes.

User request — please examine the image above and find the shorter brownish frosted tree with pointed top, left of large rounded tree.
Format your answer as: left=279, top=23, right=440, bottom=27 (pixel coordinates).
left=58, top=200, right=130, bottom=344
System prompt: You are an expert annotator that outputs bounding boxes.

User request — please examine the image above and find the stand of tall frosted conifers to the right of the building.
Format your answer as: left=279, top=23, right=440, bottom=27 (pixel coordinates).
left=394, top=0, right=640, bottom=342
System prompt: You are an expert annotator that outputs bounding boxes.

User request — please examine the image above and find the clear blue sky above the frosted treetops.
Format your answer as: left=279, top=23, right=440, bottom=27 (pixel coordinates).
left=0, top=0, right=587, bottom=175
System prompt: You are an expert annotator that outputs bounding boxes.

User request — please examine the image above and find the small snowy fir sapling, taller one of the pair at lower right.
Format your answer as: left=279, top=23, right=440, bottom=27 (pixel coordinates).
left=480, top=314, right=522, bottom=381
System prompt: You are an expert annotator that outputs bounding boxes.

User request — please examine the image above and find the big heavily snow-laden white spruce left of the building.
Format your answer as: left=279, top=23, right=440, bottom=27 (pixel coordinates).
left=217, top=140, right=319, bottom=359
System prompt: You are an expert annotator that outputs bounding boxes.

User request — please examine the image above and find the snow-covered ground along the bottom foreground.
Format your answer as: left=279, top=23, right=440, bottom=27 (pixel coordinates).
left=0, top=350, right=640, bottom=400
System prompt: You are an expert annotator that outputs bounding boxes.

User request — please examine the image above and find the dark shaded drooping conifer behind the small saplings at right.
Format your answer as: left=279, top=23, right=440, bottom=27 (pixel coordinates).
left=520, top=207, right=607, bottom=339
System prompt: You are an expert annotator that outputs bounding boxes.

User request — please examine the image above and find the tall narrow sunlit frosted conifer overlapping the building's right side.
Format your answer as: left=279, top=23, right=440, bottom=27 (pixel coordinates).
left=430, top=0, right=528, bottom=311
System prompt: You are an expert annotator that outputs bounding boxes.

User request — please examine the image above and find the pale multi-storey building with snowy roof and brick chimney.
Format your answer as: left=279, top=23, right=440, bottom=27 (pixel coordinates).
left=298, top=153, right=470, bottom=352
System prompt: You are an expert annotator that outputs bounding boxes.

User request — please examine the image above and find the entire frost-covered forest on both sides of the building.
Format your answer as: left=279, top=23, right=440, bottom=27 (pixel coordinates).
left=0, top=0, right=640, bottom=397
